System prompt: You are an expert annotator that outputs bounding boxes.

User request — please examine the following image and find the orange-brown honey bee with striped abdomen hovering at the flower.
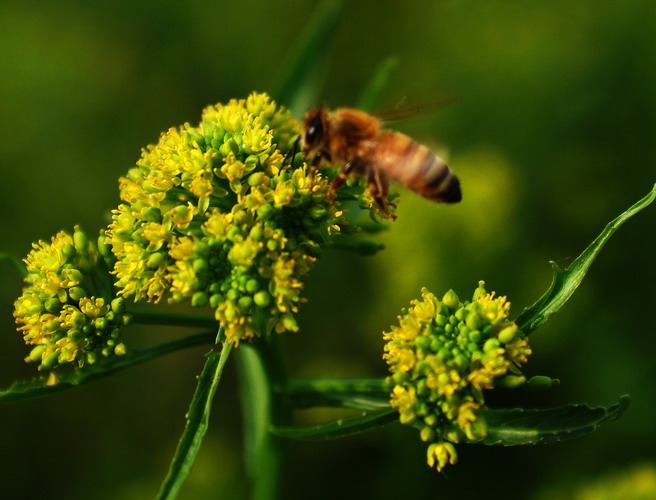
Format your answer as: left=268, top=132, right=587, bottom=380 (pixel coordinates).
left=299, top=108, right=462, bottom=217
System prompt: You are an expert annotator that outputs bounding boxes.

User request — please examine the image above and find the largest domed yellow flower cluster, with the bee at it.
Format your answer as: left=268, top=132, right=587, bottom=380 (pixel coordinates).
left=107, top=93, right=386, bottom=344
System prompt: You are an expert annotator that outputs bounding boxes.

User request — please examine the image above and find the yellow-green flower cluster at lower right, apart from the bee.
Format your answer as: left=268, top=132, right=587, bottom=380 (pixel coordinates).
left=383, top=281, right=531, bottom=471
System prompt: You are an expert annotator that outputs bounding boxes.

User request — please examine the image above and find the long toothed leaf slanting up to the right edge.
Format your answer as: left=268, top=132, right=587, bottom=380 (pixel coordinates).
left=515, top=186, right=656, bottom=334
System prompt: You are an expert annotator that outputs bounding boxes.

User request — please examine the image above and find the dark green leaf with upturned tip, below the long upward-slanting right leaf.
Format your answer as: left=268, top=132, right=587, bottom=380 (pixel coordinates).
left=479, top=396, right=630, bottom=446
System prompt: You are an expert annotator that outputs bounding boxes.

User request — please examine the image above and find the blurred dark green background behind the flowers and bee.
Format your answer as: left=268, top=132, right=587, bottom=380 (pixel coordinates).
left=0, top=0, right=656, bottom=499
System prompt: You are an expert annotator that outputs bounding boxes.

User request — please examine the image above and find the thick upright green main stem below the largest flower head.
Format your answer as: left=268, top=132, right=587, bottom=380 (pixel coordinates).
left=238, top=334, right=291, bottom=500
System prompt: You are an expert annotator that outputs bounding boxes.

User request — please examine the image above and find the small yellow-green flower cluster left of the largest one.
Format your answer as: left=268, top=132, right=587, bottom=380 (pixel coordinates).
left=14, top=227, right=130, bottom=369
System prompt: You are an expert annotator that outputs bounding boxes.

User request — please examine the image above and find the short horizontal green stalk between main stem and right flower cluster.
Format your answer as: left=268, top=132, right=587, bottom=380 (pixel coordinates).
left=287, top=379, right=392, bottom=410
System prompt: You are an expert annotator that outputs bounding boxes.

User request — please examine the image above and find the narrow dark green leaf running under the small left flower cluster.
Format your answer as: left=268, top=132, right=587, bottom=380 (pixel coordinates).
left=0, top=332, right=216, bottom=401
